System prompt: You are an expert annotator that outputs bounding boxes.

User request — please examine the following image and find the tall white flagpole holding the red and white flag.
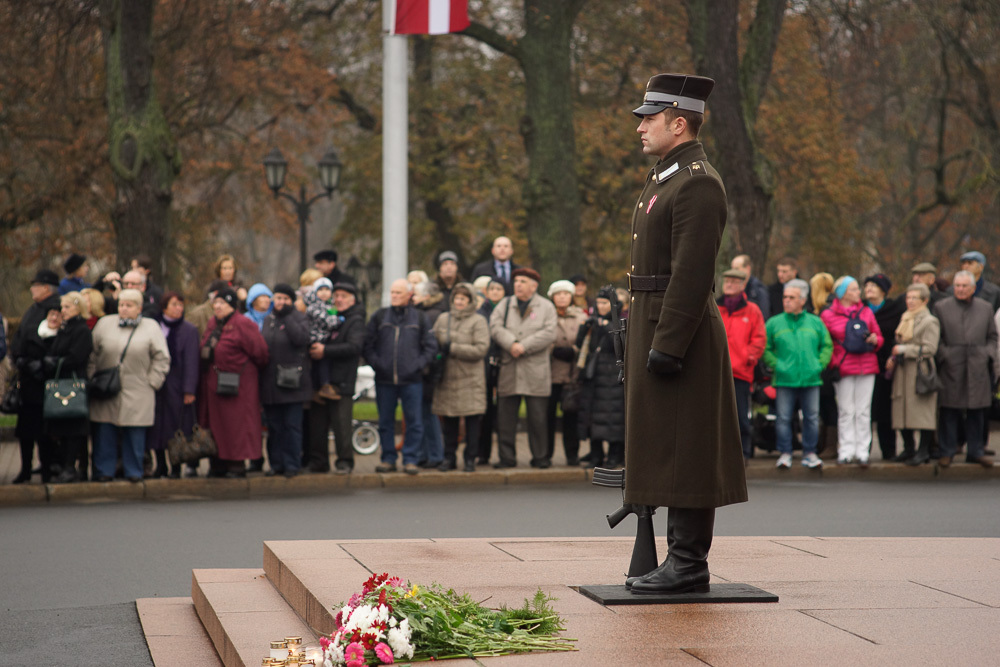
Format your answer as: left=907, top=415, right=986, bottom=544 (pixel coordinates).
left=382, top=0, right=409, bottom=306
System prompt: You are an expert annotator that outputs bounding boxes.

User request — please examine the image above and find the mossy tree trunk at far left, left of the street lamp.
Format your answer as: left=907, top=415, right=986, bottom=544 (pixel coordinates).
left=101, top=0, right=180, bottom=284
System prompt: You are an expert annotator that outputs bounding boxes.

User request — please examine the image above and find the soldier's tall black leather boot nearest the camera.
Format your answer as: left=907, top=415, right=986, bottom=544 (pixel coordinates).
left=632, top=507, right=715, bottom=593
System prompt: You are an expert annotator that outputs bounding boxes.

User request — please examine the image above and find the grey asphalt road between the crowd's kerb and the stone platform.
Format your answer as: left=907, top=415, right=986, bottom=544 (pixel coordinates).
left=0, top=480, right=1000, bottom=666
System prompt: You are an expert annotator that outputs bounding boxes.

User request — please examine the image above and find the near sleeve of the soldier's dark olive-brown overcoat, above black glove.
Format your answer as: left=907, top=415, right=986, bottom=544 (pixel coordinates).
left=652, top=176, right=726, bottom=358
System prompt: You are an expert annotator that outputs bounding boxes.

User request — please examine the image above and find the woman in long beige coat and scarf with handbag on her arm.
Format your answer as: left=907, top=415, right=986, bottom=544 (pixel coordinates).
left=886, top=283, right=941, bottom=466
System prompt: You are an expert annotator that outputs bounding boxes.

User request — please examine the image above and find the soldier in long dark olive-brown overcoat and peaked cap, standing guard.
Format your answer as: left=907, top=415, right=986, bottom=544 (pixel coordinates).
left=625, top=74, right=747, bottom=593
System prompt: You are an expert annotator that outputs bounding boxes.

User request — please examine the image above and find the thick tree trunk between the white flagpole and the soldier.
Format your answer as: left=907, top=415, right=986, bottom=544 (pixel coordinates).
left=465, top=0, right=586, bottom=284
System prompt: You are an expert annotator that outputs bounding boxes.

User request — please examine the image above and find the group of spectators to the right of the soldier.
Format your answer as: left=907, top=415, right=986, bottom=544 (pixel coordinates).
left=718, top=251, right=1000, bottom=469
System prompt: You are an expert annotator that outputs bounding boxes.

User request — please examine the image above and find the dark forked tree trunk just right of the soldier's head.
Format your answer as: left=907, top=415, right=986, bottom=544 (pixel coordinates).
left=687, top=0, right=787, bottom=275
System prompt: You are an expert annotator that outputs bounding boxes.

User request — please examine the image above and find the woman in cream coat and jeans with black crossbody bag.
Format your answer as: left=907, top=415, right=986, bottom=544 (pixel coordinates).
left=87, top=289, right=170, bottom=482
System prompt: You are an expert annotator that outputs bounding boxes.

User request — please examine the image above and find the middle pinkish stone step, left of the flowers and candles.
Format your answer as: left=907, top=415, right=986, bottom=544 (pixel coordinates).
left=191, top=569, right=319, bottom=667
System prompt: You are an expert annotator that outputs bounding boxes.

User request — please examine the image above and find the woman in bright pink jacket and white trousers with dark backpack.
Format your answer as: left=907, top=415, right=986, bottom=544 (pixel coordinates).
left=820, top=276, right=883, bottom=468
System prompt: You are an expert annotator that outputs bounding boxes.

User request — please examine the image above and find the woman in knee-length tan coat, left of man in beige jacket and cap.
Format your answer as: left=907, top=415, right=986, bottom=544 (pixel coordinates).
left=431, top=283, right=490, bottom=472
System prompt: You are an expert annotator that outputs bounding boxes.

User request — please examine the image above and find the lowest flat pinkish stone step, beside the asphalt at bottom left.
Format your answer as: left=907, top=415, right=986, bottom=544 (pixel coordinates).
left=135, top=598, right=222, bottom=667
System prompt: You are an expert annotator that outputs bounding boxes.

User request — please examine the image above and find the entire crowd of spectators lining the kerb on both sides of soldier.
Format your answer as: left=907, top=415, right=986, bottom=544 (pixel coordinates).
left=0, top=241, right=1000, bottom=483
